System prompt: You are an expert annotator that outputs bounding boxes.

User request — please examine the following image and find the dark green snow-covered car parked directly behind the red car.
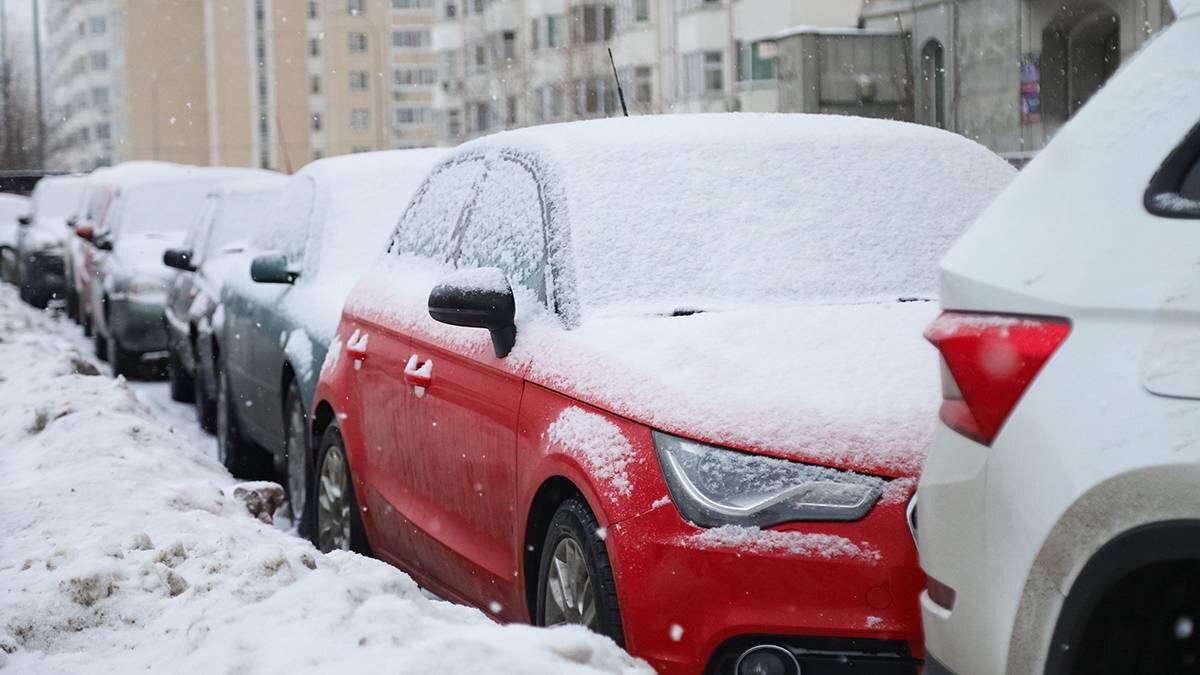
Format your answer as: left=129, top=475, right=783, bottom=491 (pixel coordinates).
left=214, top=150, right=445, bottom=516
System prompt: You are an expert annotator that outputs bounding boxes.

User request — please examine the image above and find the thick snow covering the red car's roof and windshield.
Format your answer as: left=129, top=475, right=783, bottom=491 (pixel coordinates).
left=460, top=113, right=1015, bottom=319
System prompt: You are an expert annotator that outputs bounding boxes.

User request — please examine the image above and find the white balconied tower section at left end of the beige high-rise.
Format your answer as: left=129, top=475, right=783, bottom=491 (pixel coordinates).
left=44, top=0, right=127, bottom=171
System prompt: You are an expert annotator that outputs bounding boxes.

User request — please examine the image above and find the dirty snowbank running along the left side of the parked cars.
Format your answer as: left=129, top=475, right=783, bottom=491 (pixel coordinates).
left=0, top=286, right=649, bottom=674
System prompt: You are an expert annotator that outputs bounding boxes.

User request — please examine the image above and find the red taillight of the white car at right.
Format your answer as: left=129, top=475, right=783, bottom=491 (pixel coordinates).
left=925, top=312, right=1070, bottom=446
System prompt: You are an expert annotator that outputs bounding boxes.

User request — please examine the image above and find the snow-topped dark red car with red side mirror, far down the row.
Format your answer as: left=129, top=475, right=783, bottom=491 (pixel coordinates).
left=62, top=161, right=182, bottom=338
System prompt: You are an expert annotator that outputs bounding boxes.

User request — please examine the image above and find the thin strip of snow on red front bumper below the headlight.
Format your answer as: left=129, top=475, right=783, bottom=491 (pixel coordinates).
left=682, top=525, right=882, bottom=562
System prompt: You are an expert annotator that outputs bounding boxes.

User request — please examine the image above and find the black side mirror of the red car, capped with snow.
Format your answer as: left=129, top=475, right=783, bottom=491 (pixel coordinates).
left=430, top=267, right=517, bottom=359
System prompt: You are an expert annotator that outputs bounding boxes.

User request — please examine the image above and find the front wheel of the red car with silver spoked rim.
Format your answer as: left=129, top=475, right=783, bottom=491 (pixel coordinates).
left=534, top=497, right=625, bottom=646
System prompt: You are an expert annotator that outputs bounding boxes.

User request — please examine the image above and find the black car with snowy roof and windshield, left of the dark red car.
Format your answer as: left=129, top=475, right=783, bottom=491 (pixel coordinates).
left=17, top=175, right=88, bottom=307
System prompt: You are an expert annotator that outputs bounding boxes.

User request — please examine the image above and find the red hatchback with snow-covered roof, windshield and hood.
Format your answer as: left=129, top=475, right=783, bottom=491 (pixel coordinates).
left=313, top=114, right=1013, bottom=675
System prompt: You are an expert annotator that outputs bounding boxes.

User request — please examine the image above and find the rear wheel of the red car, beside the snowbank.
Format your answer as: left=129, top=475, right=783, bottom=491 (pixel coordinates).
left=312, top=423, right=371, bottom=555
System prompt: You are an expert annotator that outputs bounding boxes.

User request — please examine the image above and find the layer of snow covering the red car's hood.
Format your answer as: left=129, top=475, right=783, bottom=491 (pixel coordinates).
left=530, top=303, right=941, bottom=477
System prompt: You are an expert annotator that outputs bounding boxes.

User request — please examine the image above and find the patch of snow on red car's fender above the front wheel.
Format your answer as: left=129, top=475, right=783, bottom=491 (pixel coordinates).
left=546, top=407, right=637, bottom=497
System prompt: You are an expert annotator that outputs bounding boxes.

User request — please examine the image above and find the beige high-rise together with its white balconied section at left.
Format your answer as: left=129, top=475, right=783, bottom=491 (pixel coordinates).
left=47, top=0, right=436, bottom=172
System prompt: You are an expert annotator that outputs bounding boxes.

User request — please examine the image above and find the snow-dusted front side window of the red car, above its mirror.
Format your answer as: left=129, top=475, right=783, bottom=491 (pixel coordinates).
left=455, top=159, right=546, bottom=300
